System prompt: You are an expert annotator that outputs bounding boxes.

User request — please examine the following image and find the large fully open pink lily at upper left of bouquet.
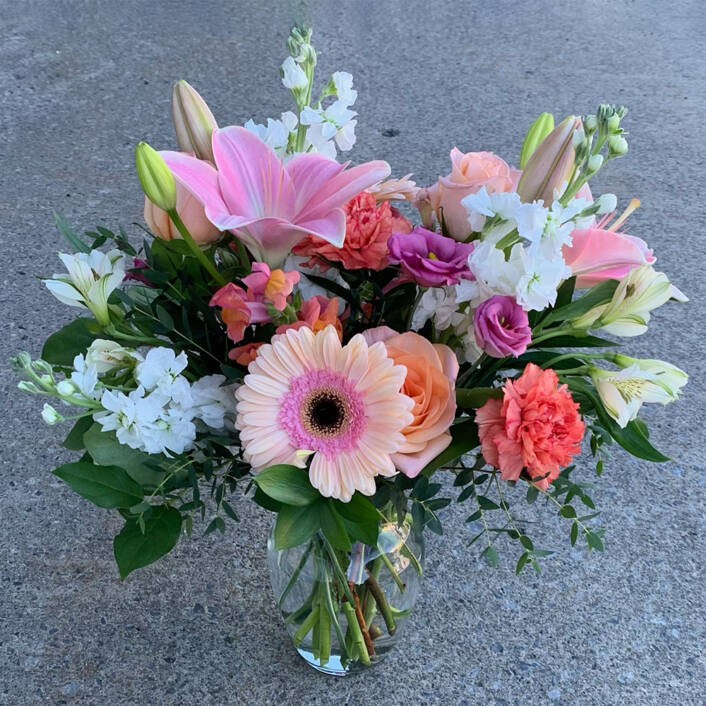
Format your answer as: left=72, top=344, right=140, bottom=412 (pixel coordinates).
left=161, top=127, right=390, bottom=267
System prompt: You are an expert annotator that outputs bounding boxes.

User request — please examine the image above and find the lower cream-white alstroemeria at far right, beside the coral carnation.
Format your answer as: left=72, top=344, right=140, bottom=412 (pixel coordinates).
left=590, top=365, right=674, bottom=428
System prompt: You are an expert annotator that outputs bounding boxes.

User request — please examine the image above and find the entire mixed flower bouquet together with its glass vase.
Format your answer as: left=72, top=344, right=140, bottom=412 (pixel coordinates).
left=14, top=28, right=687, bottom=673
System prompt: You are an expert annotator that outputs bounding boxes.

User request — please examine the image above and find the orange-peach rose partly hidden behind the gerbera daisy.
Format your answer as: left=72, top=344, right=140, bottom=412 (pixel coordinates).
left=363, top=326, right=458, bottom=478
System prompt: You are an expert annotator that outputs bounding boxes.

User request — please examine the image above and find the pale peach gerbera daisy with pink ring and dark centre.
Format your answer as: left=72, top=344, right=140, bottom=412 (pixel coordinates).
left=235, top=326, right=414, bottom=502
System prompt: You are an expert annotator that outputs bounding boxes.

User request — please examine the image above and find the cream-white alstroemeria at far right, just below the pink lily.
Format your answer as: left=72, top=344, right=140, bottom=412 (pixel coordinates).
left=575, top=265, right=686, bottom=336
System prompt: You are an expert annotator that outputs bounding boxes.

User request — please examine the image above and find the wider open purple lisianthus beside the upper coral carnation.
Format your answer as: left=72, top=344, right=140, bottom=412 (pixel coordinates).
left=387, top=227, right=473, bottom=287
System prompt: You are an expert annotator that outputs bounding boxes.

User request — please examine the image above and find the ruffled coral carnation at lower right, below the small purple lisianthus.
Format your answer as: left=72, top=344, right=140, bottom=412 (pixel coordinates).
left=476, top=363, right=584, bottom=490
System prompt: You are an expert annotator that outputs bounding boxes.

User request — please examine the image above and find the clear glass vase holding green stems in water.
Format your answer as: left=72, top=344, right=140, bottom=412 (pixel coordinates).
left=267, top=518, right=424, bottom=675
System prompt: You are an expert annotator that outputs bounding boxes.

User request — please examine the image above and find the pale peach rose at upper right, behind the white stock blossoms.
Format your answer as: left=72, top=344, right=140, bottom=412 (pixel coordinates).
left=424, top=147, right=521, bottom=240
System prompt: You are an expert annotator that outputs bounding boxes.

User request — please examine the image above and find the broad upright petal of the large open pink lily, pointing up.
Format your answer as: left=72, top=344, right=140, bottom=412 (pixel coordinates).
left=213, top=127, right=296, bottom=220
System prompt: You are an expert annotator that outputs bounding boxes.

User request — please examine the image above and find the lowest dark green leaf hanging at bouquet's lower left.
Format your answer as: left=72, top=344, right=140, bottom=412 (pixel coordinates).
left=113, top=505, right=181, bottom=579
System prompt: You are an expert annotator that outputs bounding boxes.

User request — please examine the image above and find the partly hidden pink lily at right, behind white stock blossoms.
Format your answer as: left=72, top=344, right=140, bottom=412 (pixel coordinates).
left=562, top=224, right=657, bottom=289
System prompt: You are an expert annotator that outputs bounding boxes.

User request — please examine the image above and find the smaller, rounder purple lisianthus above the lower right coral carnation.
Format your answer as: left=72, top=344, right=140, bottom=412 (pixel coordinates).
left=473, top=294, right=532, bottom=358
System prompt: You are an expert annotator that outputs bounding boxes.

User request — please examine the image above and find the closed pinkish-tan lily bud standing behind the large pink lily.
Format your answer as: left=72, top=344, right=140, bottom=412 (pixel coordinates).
left=172, top=81, right=218, bottom=162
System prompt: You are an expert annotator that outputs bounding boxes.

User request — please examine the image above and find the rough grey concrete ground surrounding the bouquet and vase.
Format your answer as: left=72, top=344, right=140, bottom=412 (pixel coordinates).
left=0, top=0, right=706, bottom=706
